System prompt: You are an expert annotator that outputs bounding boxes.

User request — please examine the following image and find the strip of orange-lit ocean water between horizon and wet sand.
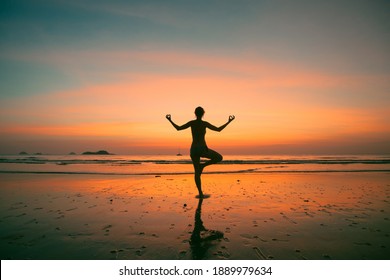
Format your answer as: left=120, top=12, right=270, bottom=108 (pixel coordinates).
left=0, top=155, right=390, bottom=176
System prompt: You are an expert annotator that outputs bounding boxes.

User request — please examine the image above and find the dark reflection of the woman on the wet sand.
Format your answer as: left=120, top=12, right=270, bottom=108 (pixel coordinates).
left=190, top=198, right=223, bottom=260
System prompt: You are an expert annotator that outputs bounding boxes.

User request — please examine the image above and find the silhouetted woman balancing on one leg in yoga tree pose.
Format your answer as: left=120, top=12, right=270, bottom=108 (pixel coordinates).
left=166, top=107, right=235, bottom=198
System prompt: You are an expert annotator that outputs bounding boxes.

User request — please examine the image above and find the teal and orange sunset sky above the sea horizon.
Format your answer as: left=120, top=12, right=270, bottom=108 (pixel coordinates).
left=0, top=0, right=390, bottom=155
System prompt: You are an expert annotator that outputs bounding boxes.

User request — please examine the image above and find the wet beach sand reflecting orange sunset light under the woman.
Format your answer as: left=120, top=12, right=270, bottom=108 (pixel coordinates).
left=0, top=172, right=390, bottom=260
